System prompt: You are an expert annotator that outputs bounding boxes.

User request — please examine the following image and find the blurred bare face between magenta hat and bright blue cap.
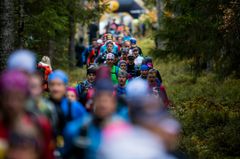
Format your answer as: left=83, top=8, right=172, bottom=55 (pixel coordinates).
left=29, top=73, right=43, bottom=100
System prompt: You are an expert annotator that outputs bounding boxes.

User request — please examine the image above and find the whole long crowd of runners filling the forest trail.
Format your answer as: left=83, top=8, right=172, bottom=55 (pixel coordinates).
left=0, top=19, right=184, bottom=159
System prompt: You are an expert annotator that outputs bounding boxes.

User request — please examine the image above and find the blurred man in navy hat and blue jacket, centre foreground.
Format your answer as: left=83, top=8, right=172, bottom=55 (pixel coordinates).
left=65, top=76, right=120, bottom=159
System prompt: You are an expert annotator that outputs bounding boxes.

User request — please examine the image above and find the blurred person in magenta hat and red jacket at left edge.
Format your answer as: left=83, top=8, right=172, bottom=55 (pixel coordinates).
left=0, top=70, right=53, bottom=159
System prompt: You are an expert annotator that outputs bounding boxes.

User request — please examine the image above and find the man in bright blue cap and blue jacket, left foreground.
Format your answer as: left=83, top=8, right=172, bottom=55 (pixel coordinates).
left=48, top=70, right=86, bottom=156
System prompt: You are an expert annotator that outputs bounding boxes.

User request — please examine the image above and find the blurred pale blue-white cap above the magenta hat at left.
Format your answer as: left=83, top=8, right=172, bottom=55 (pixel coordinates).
left=7, top=49, right=36, bottom=73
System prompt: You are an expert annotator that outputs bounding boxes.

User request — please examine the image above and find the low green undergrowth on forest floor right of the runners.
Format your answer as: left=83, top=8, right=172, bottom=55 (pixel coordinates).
left=161, top=61, right=240, bottom=159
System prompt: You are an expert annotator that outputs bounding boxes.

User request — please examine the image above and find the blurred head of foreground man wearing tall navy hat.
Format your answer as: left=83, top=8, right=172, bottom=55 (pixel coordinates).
left=93, top=79, right=117, bottom=120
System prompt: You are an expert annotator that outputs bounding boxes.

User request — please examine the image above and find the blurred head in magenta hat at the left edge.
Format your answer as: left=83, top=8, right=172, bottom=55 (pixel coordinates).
left=0, top=70, right=29, bottom=124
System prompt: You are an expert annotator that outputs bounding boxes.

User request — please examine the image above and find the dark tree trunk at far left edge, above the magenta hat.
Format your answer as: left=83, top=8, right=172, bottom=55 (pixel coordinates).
left=0, top=0, right=14, bottom=71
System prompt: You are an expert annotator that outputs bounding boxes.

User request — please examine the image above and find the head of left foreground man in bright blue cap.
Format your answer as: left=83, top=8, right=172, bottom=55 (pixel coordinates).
left=48, top=70, right=68, bottom=101
